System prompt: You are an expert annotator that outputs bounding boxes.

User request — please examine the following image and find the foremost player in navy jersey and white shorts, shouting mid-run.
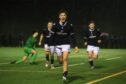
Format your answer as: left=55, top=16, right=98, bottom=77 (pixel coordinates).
left=53, top=10, right=78, bottom=81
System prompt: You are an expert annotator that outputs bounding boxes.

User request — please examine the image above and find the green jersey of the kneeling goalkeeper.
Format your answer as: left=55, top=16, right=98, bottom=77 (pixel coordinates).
left=25, top=36, right=36, bottom=48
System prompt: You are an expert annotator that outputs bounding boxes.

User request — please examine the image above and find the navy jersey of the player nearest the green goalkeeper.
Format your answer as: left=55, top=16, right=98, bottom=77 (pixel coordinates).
left=42, top=28, right=54, bottom=46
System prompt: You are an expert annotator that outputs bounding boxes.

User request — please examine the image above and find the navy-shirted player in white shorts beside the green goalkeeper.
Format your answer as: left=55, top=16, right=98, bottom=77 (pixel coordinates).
left=39, top=21, right=55, bottom=69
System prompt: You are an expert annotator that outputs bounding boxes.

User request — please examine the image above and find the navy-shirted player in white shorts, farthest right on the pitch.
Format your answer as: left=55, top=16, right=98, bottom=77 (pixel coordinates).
left=84, top=21, right=101, bottom=69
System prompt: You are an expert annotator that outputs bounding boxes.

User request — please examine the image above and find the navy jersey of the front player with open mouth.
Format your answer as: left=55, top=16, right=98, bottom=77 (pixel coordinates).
left=53, top=22, right=77, bottom=47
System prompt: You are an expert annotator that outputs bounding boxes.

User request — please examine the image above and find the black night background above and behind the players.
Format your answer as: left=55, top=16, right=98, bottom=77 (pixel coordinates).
left=0, top=0, right=126, bottom=46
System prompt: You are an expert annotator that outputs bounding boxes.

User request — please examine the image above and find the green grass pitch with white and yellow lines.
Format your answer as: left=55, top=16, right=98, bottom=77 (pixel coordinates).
left=0, top=47, right=126, bottom=84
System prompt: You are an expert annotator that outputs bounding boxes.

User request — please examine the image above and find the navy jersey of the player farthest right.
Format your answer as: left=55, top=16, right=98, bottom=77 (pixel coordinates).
left=84, top=29, right=101, bottom=46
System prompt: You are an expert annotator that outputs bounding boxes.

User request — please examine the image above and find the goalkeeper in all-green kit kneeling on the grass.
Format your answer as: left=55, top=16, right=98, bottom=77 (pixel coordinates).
left=11, top=31, right=38, bottom=64
